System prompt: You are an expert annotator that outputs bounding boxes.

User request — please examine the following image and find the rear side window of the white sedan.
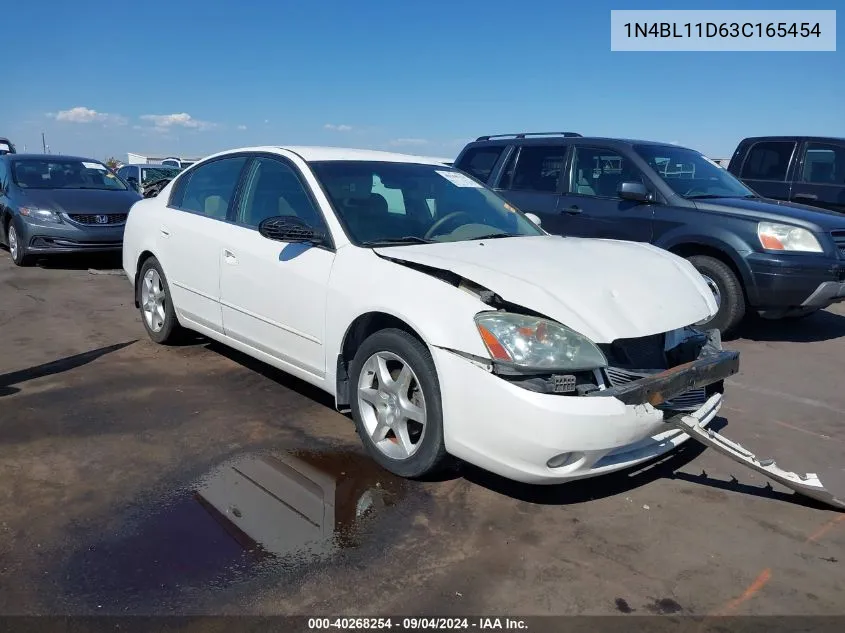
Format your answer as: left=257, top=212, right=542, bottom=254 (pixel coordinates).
left=178, top=156, right=246, bottom=220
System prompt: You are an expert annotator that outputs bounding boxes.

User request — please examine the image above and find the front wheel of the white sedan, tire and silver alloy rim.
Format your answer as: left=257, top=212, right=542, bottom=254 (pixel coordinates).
left=350, top=329, right=448, bottom=478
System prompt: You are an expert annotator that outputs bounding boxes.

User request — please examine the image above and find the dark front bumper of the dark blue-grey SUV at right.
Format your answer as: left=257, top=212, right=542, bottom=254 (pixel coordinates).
left=746, top=253, right=845, bottom=316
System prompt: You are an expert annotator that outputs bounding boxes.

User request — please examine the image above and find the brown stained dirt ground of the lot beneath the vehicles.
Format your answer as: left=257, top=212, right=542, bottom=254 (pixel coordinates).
left=0, top=251, right=845, bottom=615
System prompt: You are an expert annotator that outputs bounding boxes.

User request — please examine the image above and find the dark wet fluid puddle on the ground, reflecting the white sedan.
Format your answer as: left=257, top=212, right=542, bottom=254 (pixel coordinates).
left=56, top=451, right=412, bottom=612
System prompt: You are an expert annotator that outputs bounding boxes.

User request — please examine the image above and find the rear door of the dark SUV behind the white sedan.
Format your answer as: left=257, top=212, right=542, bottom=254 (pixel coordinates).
left=496, top=143, right=569, bottom=235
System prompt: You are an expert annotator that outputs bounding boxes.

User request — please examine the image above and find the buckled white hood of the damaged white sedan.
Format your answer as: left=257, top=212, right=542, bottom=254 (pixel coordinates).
left=374, top=235, right=717, bottom=343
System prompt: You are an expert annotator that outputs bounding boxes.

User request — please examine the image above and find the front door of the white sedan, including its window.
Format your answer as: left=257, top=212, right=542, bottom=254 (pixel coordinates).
left=220, top=156, right=335, bottom=378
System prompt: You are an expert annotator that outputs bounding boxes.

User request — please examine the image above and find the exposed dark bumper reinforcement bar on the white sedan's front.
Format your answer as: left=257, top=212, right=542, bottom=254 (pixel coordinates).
left=587, top=351, right=739, bottom=407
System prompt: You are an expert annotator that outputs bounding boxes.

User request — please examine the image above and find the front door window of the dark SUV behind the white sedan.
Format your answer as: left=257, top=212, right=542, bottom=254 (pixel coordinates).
left=569, top=147, right=645, bottom=198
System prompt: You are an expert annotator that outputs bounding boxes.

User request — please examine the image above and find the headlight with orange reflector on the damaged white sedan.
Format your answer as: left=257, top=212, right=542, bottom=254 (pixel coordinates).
left=475, top=312, right=607, bottom=371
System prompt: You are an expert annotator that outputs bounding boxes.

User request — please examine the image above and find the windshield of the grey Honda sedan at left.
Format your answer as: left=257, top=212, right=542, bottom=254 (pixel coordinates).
left=12, top=158, right=126, bottom=191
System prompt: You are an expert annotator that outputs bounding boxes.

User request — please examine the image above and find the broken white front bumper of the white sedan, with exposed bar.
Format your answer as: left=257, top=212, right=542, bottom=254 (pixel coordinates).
left=432, top=348, right=738, bottom=484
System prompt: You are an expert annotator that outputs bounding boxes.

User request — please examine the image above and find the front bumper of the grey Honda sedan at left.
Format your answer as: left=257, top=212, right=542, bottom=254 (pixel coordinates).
left=17, top=218, right=125, bottom=255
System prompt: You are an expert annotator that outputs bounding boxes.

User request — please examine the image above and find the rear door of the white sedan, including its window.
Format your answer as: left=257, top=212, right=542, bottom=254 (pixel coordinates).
left=158, top=156, right=247, bottom=332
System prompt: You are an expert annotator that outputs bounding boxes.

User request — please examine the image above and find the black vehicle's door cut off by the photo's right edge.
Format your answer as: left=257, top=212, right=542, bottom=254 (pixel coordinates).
left=791, top=141, right=845, bottom=213
